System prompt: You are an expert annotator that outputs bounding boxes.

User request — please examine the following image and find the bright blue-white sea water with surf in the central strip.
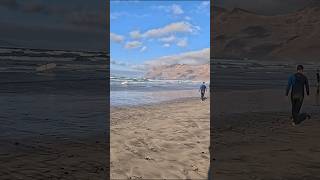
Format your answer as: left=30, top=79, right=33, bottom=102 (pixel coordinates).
left=110, top=70, right=209, bottom=106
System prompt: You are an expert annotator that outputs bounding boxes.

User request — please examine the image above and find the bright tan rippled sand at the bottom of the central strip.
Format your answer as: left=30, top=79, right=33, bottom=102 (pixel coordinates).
left=110, top=98, right=210, bottom=179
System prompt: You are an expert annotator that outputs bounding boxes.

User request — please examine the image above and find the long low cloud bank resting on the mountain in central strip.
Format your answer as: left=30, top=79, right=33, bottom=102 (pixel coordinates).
left=145, top=48, right=210, bottom=66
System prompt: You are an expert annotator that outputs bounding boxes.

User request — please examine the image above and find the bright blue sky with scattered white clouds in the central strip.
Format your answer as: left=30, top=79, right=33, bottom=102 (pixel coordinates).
left=110, top=1, right=210, bottom=69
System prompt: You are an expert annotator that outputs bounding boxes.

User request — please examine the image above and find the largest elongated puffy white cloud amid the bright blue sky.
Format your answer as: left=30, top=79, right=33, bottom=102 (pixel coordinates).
left=142, top=21, right=200, bottom=38
